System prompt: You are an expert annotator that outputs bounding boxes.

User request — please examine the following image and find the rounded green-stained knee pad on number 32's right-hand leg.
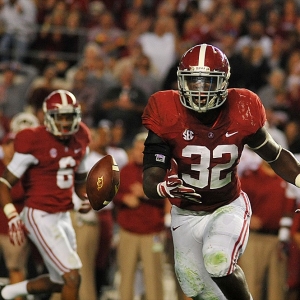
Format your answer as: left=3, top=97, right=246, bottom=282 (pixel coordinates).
left=203, top=250, right=232, bottom=277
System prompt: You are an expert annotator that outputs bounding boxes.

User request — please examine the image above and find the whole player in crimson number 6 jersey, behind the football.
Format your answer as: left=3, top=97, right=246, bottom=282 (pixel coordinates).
left=0, top=90, right=90, bottom=300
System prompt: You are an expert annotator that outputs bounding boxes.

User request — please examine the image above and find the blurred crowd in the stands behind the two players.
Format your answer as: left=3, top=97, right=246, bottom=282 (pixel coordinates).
left=0, top=0, right=300, bottom=300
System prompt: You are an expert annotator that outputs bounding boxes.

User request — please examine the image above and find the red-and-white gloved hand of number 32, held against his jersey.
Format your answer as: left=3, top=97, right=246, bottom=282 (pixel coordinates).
left=157, top=159, right=201, bottom=203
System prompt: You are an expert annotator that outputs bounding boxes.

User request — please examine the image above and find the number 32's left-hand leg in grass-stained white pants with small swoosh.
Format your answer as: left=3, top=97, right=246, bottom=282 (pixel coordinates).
left=171, top=206, right=225, bottom=300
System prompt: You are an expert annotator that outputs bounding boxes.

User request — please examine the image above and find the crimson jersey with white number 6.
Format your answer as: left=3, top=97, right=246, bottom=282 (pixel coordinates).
left=8, top=123, right=90, bottom=213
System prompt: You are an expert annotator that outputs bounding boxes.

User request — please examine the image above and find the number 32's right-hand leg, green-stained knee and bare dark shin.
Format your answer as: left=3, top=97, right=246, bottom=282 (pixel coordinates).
left=203, top=194, right=252, bottom=300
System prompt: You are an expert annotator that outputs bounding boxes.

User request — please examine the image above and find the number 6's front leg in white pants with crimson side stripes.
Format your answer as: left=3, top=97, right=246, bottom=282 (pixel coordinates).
left=22, top=207, right=82, bottom=300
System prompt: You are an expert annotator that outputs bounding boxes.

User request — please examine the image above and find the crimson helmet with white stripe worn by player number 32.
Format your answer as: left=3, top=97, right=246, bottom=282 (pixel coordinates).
left=177, top=44, right=230, bottom=113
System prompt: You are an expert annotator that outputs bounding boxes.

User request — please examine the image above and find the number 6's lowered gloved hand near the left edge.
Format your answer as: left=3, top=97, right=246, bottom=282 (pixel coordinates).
left=8, top=212, right=28, bottom=246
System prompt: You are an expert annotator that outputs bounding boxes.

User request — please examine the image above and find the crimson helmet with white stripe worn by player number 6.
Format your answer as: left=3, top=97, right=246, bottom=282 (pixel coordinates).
left=43, top=90, right=81, bottom=137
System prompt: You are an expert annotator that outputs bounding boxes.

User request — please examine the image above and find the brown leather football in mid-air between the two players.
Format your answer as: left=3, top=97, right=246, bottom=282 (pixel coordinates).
left=86, top=154, right=120, bottom=210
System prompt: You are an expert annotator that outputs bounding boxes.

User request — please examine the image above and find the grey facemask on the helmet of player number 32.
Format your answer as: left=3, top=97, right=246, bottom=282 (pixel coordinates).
left=177, top=70, right=228, bottom=113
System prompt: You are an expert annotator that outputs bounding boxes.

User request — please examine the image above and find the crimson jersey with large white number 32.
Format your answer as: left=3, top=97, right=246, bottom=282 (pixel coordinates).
left=142, top=89, right=266, bottom=211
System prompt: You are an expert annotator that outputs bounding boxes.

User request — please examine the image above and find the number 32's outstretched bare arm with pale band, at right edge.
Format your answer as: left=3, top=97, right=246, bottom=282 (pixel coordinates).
left=247, top=127, right=300, bottom=187
